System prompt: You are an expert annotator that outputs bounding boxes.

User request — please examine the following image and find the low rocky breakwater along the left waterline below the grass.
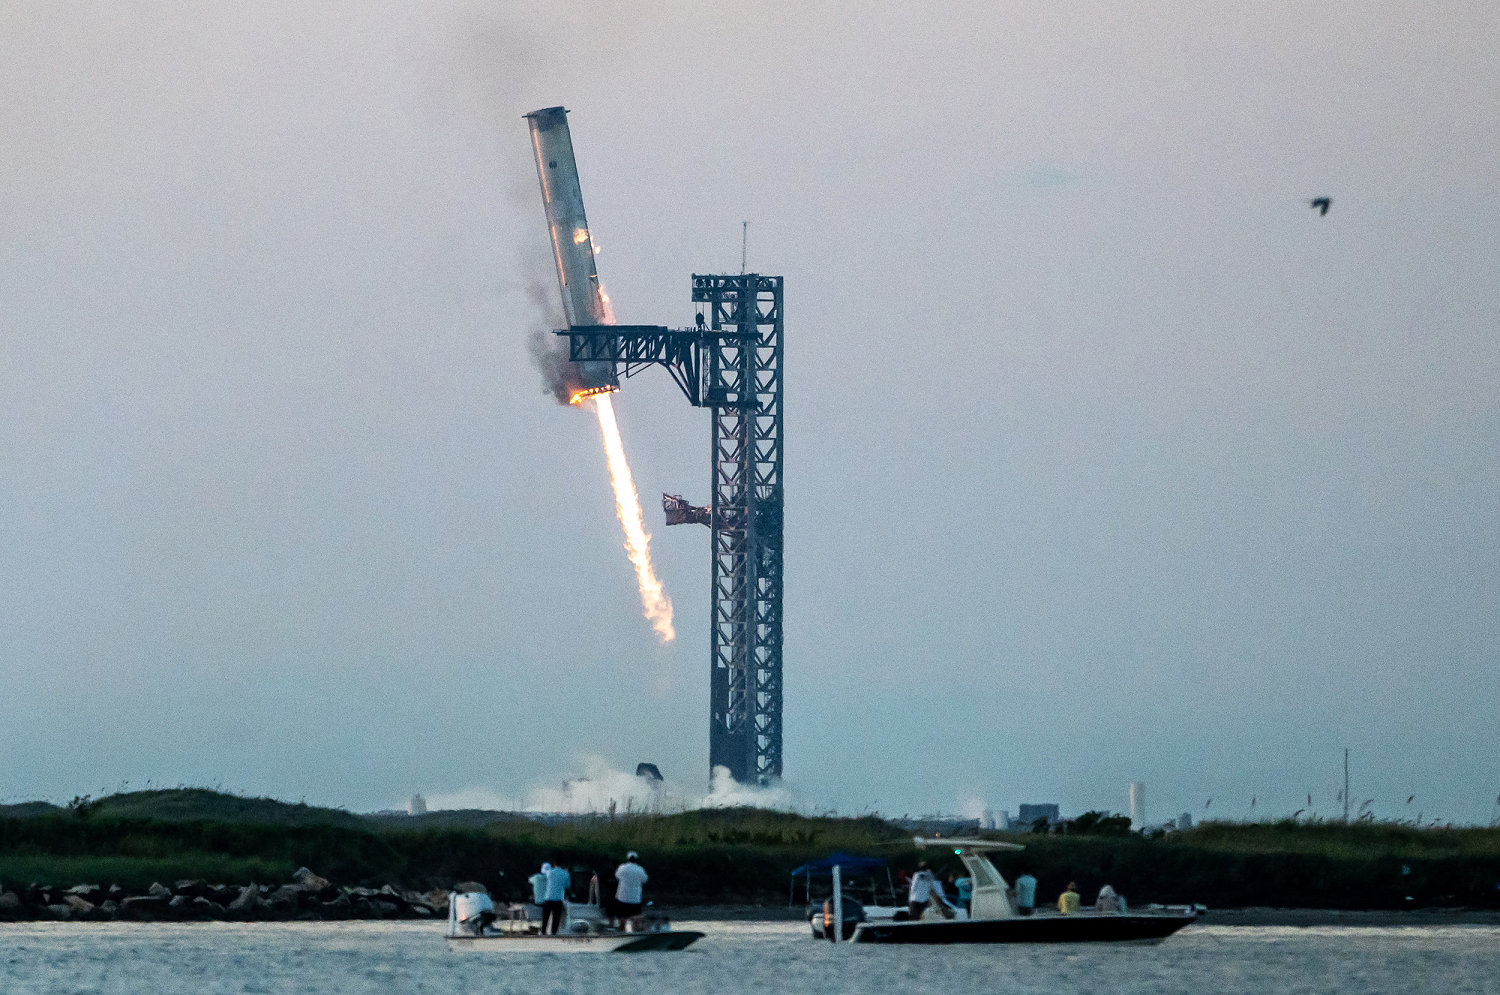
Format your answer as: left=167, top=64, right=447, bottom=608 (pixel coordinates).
left=0, top=867, right=449, bottom=923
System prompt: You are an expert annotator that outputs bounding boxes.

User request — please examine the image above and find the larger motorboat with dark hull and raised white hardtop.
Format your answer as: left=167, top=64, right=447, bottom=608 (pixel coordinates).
left=815, top=837, right=1199, bottom=944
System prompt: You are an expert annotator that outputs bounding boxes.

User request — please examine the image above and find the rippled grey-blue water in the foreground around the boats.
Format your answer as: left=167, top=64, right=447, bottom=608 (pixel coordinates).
left=0, top=923, right=1500, bottom=995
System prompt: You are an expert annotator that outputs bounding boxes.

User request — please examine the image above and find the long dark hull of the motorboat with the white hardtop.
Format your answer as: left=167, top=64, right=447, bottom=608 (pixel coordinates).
left=852, top=912, right=1197, bottom=944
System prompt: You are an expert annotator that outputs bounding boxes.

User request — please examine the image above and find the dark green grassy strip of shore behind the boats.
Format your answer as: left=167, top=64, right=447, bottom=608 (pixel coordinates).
left=0, top=789, right=1500, bottom=908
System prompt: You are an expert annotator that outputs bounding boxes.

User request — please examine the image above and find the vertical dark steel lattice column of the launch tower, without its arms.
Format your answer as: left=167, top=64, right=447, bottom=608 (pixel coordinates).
left=693, top=273, right=783, bottom=783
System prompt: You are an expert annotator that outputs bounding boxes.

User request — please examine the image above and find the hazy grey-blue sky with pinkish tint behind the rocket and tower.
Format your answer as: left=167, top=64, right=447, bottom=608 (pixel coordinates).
left=0, top=0, right=1500, bottom=821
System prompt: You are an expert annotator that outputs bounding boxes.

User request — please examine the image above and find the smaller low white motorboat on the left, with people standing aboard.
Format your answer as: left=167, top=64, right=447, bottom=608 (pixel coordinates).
left=447, top=891, right=704, bottom=953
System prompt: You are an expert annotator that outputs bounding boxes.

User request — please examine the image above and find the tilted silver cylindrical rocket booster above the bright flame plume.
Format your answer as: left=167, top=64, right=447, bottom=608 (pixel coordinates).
left=527, top=107, right=620, bottom=393
